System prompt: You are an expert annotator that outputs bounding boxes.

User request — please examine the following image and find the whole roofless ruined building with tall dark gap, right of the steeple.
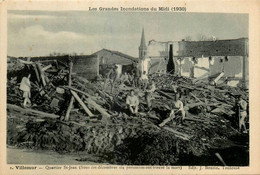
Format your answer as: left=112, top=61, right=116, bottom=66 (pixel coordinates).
left=147, top=38, right=248, bottom=86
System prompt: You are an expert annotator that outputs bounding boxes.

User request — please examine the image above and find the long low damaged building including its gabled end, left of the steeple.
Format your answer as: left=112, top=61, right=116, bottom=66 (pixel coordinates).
left=15, top=49, right=138, bottom=80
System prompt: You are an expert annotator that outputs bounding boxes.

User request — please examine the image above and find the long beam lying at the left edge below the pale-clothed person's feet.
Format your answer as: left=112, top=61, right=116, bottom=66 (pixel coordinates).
left=7, top=104, right=60, bottom=119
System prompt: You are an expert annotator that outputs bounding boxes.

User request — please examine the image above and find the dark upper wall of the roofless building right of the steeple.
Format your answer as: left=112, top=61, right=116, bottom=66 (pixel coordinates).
left=148, top=38, right=248, bottom=57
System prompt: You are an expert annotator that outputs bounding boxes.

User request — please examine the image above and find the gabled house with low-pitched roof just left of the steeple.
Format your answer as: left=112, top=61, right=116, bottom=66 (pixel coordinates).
left=92, top=49, right=138, bottom=76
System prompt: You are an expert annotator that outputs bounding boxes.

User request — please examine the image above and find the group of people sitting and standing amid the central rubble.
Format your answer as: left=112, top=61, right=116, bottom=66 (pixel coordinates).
left=104, top=65, right=186, bottom=126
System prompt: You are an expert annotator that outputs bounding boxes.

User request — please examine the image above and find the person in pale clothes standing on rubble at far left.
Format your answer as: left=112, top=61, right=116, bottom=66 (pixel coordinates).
left=20, top=74, right=31, bottom=107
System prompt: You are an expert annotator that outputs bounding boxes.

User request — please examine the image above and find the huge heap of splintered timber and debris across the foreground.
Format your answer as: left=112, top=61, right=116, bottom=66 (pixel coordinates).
left=7, top=58, right=248, bottom=165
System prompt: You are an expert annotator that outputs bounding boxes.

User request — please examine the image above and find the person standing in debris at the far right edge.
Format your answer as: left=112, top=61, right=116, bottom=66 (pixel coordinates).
left=237, top=95, right=247, bottom=133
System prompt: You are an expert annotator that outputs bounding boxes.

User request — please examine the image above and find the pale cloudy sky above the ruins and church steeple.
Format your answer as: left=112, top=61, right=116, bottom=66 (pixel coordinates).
left=7, top=11, right=249, bottom=57
